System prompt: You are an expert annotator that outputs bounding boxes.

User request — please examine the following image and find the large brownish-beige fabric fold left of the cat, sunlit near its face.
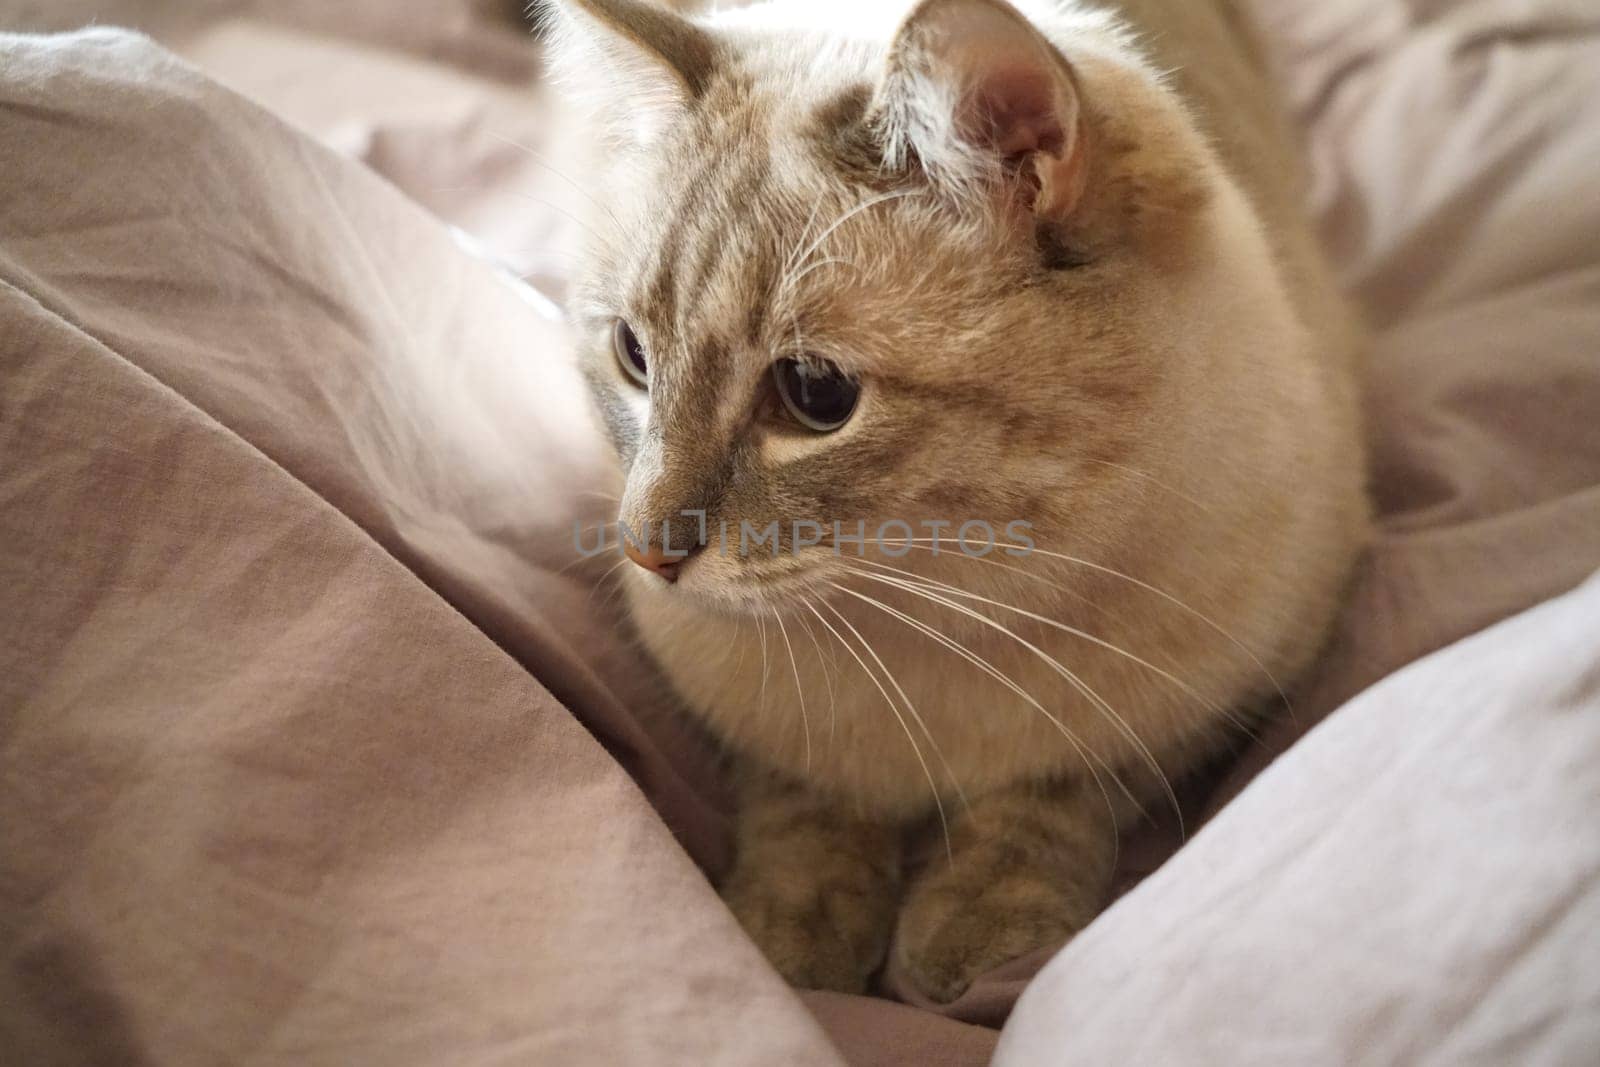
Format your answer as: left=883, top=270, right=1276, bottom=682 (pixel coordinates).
left=0, top=32, right=840, bottom=1065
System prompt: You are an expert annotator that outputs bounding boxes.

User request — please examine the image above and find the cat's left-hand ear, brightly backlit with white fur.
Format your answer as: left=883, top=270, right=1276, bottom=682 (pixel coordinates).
left=542, top=0, right=717, bottom=146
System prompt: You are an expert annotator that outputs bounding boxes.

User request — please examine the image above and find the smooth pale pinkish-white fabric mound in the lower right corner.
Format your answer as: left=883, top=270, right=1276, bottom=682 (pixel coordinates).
left=994, top=576, right=1600, bottom=1067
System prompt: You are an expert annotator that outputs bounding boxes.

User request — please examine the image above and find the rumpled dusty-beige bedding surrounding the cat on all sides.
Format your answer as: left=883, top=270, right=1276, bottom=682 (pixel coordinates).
left=0, top=0, right=1600, bottom=1064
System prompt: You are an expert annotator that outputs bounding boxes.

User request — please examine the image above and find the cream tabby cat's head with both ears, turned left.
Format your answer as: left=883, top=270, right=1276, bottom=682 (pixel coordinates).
left=552, top=0, right=1235, bottom=605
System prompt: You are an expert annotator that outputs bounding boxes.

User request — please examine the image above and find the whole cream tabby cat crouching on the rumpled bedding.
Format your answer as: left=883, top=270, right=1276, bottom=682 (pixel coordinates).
left=547, top=0, right=1368, bottom=1001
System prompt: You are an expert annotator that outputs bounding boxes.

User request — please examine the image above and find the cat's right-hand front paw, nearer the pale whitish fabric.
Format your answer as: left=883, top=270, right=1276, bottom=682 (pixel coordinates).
left=894, top=872, right=1096, bottom=1005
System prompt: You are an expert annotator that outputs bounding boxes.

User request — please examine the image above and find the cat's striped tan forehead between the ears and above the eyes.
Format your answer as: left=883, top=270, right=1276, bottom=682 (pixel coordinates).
left=611, top=56, right=1005, bottom=404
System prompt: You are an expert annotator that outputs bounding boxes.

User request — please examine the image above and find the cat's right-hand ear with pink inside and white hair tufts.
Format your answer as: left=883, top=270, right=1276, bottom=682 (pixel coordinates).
left=874, top=0, right=1088, bottom=219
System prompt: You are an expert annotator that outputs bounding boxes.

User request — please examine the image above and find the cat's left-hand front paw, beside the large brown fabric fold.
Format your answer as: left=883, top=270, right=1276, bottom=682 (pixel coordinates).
left=722, top=873, right=894, bottom=993
